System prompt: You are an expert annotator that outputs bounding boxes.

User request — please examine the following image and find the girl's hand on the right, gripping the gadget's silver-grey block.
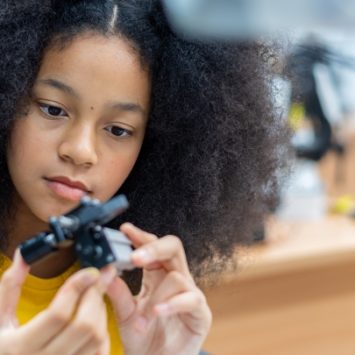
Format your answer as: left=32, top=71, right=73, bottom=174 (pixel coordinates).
left=108, top=223, right=212, bottom=355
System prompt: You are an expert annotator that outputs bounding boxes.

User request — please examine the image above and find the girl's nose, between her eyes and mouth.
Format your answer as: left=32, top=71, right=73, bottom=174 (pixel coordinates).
left=58, top=124, right=98, bottom=167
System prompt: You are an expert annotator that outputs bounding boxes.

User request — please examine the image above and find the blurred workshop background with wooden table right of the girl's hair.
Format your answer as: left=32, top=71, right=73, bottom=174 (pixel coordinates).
left=164, top=0, right=355, bottom=355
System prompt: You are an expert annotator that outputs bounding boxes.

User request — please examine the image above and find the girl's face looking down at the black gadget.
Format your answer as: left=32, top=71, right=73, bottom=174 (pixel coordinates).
left=7, top=35, right=150, bottom=222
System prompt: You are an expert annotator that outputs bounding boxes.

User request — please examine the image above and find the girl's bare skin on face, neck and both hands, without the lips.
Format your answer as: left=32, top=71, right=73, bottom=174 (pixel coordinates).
left=0, top=34, right=211, bottom=355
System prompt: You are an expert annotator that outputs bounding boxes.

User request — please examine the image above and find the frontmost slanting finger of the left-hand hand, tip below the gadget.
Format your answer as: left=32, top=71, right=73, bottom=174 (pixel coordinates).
left=18, top=268, right=100, bottom=349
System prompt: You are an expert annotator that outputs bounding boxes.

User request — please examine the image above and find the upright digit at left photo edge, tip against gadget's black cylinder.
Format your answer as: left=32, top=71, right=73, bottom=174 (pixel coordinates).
left=0, top=249, right=30, bottom=326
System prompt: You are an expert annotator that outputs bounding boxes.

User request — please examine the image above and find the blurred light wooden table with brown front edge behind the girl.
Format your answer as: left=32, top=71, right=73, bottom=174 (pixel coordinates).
left=204, top=216, right=355, bottom=355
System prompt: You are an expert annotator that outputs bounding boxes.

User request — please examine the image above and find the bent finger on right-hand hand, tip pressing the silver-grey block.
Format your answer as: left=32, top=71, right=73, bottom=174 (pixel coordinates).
left=131, top=236, right=191, bottom=277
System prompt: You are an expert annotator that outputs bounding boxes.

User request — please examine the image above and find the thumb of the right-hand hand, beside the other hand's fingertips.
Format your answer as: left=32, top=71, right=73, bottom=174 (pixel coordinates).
left=106, top=277, right=136, bottom=325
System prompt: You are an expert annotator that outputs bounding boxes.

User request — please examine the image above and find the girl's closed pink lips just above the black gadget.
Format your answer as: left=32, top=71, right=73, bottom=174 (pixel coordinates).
left=44, top=176, right=91, bottom=201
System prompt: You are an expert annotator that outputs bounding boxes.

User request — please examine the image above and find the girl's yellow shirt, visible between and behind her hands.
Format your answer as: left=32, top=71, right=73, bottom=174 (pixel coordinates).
left=0, top=255, right=123, bottom=355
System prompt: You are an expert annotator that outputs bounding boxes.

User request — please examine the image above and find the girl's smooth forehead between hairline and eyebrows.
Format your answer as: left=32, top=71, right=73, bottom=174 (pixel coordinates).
left=37, top=34, right=150, bottom=110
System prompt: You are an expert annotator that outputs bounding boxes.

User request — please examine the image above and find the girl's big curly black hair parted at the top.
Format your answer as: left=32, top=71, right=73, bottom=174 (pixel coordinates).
left=0, top=0, right=288, bottom=290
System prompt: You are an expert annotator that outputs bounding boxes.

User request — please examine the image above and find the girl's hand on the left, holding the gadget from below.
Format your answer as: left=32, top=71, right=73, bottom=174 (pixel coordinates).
left=0, top=250, right=116, bottom=355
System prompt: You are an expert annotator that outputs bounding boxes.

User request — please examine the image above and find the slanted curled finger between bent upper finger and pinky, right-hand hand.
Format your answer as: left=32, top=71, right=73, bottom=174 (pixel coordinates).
left=138, top=271, right=195, bottom=317
